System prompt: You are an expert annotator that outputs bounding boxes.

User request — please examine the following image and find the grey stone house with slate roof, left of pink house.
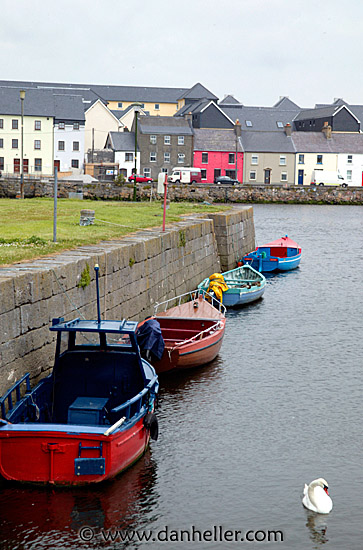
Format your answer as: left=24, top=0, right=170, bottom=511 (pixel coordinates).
left=133, top=116, right=193, bottom=179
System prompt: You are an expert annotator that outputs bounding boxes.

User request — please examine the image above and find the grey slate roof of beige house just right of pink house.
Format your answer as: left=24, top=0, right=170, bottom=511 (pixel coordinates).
left=241, top=130, right=295, bottom=153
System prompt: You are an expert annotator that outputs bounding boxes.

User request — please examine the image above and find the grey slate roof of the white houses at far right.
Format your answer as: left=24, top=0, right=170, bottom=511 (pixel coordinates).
left=291, top=132, right=363, bottom=154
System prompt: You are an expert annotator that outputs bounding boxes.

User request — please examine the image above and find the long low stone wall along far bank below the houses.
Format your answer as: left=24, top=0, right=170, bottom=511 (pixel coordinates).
left=0, top=178, right=363, bottom=205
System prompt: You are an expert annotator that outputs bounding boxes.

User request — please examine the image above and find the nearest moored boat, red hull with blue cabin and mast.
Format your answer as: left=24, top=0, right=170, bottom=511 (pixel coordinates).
left=0, top=266, right=159, bottom=485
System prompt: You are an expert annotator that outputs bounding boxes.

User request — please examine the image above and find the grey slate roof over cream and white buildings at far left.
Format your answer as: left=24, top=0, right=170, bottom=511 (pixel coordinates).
left=0, top=87, right=85, bottom=122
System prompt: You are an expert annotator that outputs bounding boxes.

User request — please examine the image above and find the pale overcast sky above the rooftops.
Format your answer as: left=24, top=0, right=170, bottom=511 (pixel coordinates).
left=0, top=0, right=363, bottom=107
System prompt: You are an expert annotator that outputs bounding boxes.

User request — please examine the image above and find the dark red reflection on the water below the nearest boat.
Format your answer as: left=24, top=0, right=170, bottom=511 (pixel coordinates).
left=0, top=450, right=158, bottom=549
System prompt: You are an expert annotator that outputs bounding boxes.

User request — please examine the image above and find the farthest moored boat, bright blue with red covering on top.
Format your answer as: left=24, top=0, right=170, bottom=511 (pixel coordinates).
left=243, top=235, right=301, bottom=273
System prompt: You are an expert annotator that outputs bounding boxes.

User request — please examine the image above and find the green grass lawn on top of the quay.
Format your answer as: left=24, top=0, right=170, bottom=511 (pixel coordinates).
left=0, top=199, right=228, bottom=265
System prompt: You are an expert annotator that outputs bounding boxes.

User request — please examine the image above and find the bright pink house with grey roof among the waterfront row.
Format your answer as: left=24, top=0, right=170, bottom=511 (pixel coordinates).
left=193, top=124, right=243, bottom=183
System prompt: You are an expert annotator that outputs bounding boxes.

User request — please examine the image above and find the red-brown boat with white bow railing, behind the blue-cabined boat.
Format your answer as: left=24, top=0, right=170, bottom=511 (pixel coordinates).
left=138, top=289, right=226, bottom=374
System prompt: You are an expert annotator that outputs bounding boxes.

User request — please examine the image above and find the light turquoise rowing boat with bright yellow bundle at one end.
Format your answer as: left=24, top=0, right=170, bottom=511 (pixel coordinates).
left=198, top=265, right=266, bottom=307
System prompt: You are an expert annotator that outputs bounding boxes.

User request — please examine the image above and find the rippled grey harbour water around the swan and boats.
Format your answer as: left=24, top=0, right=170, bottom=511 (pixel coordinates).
left=0, top=205, right=363, bottom=550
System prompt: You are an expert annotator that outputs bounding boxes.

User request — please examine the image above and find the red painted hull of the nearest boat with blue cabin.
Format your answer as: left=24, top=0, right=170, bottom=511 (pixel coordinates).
left=0, top=418, right=149, bottom=485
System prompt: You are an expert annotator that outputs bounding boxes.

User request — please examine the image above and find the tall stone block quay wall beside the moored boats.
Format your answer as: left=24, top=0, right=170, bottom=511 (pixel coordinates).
left=0, top=207, right=255, bottom=395
